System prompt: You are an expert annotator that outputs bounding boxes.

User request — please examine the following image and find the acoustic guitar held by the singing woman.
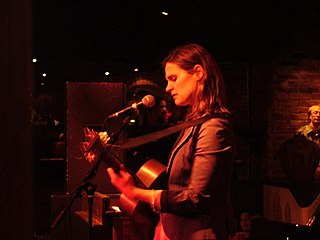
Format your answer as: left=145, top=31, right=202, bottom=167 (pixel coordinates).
left=81, top=128, right=166, bottom=240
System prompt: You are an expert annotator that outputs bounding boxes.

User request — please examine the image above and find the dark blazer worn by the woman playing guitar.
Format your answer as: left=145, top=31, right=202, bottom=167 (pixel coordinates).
left=160, top=118, right=235, bottom=240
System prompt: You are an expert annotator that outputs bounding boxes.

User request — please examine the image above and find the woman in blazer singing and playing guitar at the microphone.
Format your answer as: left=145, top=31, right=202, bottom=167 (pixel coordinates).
left=107, top=44, right=235, bottom=240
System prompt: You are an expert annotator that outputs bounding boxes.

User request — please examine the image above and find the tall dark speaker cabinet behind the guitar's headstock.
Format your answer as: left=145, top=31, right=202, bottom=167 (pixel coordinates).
left=66, top=82, right=125, bottom=193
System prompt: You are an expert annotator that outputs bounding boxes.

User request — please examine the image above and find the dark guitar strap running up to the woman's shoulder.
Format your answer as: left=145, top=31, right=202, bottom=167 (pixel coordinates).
left=120, top=113, right=225, bottom=149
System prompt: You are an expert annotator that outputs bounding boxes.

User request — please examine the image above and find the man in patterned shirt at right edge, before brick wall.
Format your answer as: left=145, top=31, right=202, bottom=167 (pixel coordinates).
left=297, top=104, right=320, bottom=180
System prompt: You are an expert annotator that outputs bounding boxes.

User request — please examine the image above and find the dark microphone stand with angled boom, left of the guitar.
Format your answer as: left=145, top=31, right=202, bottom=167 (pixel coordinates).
left=51, top=116, right=130, bottom=240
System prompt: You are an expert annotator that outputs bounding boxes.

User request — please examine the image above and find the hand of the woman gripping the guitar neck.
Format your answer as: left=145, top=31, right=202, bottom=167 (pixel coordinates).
left=107, top=164, right=135, bottom=195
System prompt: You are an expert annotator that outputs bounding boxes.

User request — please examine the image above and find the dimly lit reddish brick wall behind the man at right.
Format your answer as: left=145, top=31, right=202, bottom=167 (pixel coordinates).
left=250, top=60, right=320, bottom=178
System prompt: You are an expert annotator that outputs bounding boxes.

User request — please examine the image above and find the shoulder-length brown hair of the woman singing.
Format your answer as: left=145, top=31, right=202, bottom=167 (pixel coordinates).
left=162, top=43, right=229, bottom=120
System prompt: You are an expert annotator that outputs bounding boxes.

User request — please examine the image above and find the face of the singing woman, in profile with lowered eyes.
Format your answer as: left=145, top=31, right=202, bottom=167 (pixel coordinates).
left=165, top=62, right=197, bottom=106
